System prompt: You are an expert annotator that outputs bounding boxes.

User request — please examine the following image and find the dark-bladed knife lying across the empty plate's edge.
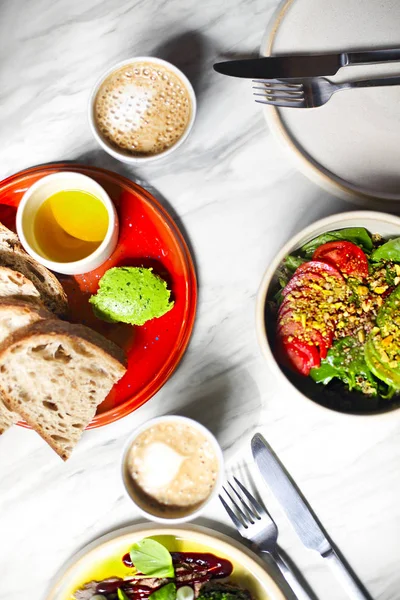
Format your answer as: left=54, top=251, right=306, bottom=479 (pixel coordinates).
left=214, top=48, right=400, bottom=79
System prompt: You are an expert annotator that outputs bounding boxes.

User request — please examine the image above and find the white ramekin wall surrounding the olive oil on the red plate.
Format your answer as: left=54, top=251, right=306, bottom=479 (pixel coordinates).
left=16, top=171, right=118, bottom=275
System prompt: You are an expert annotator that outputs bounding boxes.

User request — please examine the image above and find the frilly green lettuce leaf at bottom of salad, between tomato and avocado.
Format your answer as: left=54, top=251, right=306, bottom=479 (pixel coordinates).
left=310, top=337, right=378, bottom=396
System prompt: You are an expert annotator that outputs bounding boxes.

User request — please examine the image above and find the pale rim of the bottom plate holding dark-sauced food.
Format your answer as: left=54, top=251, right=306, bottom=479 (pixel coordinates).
left=44, top=522, right=286, bottom=600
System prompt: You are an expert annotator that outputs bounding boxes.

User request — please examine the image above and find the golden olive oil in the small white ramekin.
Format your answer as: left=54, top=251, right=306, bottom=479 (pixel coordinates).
left=34, top=190, right=108, bottom=262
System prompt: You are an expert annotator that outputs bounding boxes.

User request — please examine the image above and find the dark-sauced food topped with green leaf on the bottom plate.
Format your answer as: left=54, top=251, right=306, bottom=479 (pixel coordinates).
left=73, top=538, right=252, bottom=600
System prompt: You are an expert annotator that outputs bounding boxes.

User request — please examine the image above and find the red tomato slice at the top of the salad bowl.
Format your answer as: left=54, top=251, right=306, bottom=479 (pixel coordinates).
left=312, top=240, right=368, bottom=279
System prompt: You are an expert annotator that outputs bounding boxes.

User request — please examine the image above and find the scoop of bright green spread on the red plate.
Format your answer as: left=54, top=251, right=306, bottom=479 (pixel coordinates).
left=89, top=267, right=174, bottom=325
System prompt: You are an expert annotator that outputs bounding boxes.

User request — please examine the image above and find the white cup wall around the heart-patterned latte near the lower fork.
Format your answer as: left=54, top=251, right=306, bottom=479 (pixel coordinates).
left=122, top=415, right=224, bottom=524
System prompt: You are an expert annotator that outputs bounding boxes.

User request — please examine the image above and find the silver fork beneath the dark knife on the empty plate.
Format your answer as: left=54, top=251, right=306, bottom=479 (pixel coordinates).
left=253, top=77, right=400, bottom=108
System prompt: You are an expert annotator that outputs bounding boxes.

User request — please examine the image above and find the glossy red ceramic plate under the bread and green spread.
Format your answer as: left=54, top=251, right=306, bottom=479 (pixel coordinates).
left=0, top=164, right=197, bottom=428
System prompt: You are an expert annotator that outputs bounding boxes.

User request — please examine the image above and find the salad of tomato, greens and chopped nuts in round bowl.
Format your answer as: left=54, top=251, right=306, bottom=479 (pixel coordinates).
left=270, top=227, right=400, bottom=408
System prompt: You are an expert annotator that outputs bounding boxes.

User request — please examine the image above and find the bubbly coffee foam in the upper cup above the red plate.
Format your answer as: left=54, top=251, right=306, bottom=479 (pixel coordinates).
left=94, top=62, right=192, bottom=156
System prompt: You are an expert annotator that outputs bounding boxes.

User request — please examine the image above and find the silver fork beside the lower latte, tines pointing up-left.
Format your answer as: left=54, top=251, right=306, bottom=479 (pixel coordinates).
left=219, top=477, right=311, bottom=600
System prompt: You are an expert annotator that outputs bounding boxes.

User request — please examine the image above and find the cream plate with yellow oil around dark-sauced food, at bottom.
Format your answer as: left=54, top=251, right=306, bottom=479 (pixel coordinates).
left=46, top=524, right=285, bottom=600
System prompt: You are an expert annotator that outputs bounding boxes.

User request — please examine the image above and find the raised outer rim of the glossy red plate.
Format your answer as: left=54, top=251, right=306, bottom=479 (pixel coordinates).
left=0, top=161, right=198, bottom=430
